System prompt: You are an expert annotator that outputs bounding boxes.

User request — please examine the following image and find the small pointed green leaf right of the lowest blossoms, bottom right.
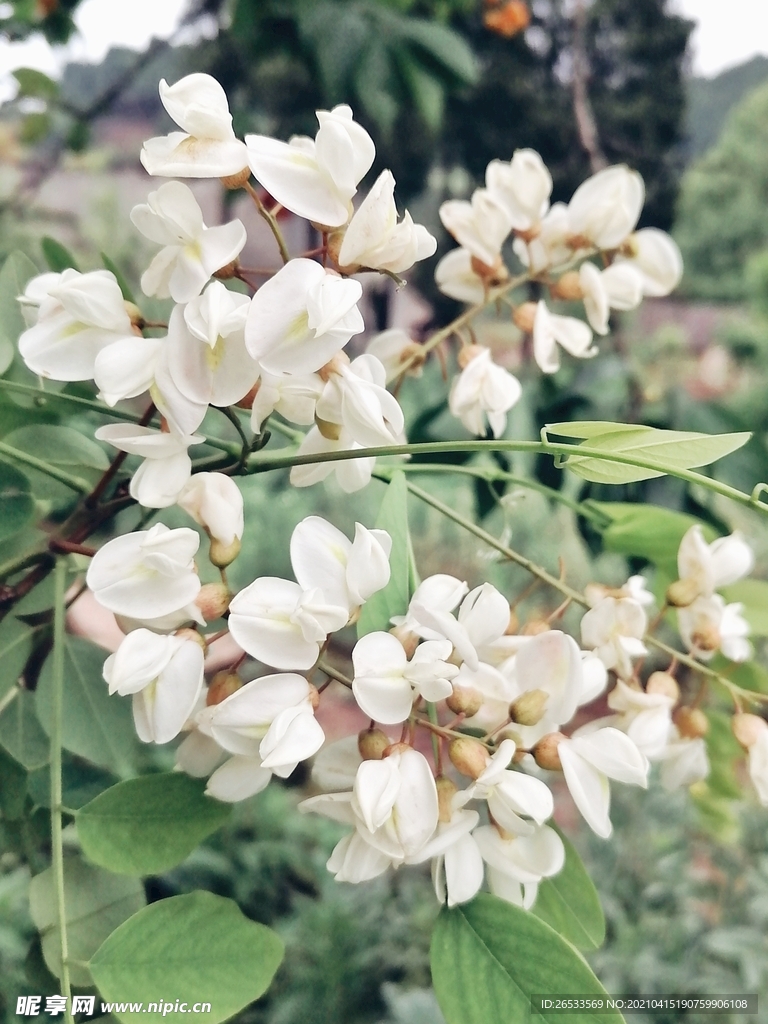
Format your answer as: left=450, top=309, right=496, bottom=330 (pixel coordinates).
left=534, top=828, right=605, bottom=949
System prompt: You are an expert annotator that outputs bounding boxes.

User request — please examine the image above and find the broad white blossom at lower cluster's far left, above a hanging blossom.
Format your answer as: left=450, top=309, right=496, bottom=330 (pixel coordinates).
left=85, top=522, right=201, bottom=621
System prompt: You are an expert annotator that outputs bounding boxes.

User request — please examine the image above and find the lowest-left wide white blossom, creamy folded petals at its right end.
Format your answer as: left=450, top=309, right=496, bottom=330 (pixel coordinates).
left=198, top=673, right=326, bottom=778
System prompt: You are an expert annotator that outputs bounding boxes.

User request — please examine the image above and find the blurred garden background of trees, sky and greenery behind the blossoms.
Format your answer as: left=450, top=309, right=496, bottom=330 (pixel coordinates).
left=0, top=0, right=768, bottom=1024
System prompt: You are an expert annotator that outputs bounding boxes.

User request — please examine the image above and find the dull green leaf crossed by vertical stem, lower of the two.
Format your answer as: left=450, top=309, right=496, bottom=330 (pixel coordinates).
left=30, top=857, right=146, bottom=985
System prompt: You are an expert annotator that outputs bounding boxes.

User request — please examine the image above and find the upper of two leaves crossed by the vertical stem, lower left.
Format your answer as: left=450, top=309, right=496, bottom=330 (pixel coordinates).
left=35, top=636, right=136, bottom=775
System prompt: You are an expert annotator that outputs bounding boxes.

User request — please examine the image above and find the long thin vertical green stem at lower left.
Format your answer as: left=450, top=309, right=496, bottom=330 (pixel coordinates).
left=50, top=558, right=72, bottom=1024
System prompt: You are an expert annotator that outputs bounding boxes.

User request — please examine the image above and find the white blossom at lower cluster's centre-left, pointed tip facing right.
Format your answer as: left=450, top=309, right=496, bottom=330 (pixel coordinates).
left=228, top=577, right=349, bottom=671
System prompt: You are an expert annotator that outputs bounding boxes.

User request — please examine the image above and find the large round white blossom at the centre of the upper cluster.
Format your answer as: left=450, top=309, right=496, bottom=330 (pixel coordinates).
left=246, top=259, right=365, bottom=374
